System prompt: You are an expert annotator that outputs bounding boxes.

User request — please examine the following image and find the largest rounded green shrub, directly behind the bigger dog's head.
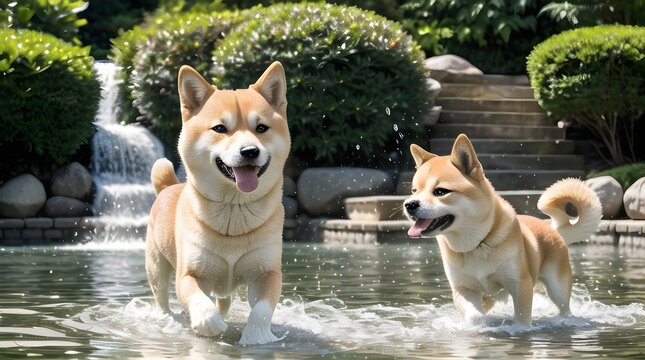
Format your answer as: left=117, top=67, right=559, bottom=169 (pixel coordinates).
left=214, top=3, right=426, bottom=165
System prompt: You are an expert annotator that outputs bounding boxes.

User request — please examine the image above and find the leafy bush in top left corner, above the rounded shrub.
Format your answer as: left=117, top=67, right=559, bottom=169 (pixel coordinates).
left=0, top=0, right=88, bottom=45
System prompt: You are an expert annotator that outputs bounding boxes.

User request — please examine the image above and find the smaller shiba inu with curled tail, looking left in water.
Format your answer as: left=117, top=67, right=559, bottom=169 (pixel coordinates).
left=403, top=134, right=602, bottom=326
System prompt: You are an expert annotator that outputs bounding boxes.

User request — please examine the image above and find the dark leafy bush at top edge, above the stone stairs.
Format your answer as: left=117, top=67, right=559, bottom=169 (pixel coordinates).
left=401, top=0, right=554, bottom=74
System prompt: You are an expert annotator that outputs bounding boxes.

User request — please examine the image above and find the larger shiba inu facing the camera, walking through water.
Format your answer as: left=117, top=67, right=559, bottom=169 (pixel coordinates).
left=146, top=62, right=291, bottom=344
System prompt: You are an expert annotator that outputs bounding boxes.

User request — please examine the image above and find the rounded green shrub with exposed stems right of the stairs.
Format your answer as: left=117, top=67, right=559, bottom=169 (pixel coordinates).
left=527, top=25, right=645, bottom=165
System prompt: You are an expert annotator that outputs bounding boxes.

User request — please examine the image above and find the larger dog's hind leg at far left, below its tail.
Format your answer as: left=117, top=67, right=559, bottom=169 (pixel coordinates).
left=146, top=236, right=174, bottom=313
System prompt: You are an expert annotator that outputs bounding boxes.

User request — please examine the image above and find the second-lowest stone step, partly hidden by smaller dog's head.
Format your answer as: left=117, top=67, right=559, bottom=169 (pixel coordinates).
left=396, top=170, right=585, bottom=195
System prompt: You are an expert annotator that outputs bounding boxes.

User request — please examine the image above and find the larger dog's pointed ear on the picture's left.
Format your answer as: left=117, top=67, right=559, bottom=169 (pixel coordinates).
left=177, top=65, right=217, bottom=121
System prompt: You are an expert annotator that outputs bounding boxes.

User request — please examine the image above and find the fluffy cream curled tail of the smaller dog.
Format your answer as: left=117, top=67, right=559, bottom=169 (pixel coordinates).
left=538, top=178, right=602, bottom=245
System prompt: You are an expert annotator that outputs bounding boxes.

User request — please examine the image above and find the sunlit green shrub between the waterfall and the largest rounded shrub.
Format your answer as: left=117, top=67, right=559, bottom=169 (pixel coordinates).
left=129, top=12, right=238, bottom=148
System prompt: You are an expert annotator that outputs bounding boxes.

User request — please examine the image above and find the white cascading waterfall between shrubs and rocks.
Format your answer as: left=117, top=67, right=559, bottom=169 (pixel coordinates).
left=90, top=62, right=163, bottom=240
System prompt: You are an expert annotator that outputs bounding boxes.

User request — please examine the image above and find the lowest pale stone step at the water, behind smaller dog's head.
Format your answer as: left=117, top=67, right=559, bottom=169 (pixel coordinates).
left=345, top=190, right=546, bottom=221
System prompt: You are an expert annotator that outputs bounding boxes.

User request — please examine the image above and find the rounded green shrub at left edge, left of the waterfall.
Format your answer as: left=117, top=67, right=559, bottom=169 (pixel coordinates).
left=0, top=29, right=100, bottom=180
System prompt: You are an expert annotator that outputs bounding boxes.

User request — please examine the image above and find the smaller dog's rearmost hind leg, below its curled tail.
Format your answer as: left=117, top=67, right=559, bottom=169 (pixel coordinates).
left=540, top=256, right=573, bottom=315
